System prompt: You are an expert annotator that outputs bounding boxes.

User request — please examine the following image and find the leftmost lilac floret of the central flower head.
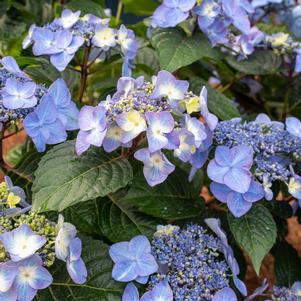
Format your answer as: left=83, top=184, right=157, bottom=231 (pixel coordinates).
left=76, top=106, right=107, bottom=155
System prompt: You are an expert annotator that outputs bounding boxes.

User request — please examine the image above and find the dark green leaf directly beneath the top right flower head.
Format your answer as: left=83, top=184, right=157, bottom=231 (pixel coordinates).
left=226, top=50, right=282, bottom=75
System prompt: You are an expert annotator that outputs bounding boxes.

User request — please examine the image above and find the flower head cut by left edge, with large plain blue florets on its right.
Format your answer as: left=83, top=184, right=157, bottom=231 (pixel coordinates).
left=0, top=57, right=78, bottom=152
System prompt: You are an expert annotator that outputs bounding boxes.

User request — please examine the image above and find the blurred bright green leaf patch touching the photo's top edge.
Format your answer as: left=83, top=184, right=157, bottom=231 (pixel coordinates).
left=123, top=0, right=158, bottom=16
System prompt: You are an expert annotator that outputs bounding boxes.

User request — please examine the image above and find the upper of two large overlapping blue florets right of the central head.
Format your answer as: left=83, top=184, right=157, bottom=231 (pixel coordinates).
left=207, top=145, right=253, bottom=193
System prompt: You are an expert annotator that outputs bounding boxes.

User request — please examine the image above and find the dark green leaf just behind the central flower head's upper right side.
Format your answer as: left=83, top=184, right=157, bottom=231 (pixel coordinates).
left=189, top=77, right=240, bottom=120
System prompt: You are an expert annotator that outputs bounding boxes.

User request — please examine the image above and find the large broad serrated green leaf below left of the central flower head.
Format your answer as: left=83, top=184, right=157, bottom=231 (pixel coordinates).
left=32, top=141, right=133, bottom=211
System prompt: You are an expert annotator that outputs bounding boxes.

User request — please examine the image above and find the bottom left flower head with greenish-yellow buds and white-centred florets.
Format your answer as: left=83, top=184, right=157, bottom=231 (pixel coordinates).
left=0, top=177, right=87, bottom=301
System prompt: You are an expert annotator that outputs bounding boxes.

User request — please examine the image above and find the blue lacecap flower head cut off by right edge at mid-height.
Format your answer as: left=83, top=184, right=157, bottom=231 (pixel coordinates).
left=207, top=114, right=301, bottom=217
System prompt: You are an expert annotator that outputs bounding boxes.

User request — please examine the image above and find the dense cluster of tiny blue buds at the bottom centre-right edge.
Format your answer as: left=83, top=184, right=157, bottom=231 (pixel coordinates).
left=151, top=225, right=231, bottom=301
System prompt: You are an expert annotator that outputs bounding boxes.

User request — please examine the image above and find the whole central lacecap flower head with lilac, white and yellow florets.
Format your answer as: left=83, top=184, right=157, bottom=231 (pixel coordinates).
left=76, top=71, right=218, bottom=186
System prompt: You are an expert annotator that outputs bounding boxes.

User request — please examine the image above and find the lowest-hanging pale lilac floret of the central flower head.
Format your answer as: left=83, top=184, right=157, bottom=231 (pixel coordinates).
left=134, top=148, right=175, bottom=187
